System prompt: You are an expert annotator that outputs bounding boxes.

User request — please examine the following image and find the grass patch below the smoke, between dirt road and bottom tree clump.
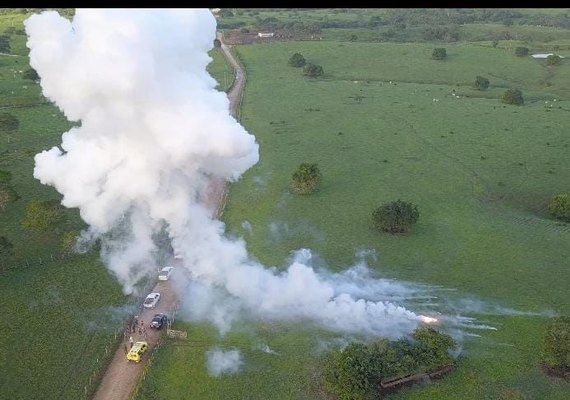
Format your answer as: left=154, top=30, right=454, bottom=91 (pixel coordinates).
left=136, top=322, right=338, bottom=400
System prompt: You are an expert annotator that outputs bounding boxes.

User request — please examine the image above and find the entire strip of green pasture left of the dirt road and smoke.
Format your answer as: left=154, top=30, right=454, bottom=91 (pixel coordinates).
left=0, top=13, right=125, bottom=400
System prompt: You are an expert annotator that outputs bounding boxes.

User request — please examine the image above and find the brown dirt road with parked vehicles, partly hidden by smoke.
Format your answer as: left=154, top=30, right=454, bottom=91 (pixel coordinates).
left=93, top=32, right=245, bottom=400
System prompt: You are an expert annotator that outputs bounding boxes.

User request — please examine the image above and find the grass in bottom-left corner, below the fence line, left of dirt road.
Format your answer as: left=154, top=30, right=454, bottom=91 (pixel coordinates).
left=0, top=255, right=124, bottom=400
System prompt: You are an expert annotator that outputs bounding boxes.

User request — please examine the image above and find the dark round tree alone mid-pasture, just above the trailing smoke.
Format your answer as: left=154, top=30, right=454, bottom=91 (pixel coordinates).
left=372, top=199, right=420, bottom=233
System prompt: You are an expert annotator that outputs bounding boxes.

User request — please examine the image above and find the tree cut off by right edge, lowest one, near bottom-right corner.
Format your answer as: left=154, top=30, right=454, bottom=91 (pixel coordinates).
left=542, top=316, right=570, bottom=373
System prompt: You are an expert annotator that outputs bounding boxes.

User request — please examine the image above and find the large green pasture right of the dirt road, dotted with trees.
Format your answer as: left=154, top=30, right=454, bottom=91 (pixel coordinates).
left=140, top=41, right=570, bottom=400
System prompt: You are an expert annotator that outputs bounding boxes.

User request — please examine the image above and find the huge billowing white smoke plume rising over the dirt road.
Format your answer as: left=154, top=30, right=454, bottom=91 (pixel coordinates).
left=25, top=9, right=450, bottom=338
